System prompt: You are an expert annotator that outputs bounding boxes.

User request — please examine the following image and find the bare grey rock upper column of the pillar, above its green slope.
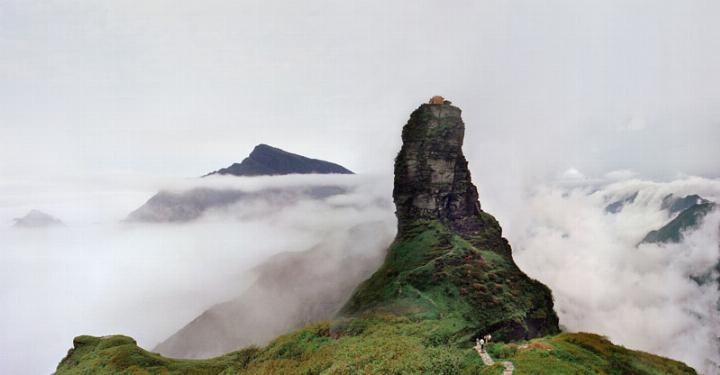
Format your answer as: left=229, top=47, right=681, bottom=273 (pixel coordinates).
left=393, top=104, right=480, bottom=232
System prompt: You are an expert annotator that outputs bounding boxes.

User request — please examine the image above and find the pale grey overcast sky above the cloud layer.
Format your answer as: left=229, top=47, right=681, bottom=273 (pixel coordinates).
left=0, top=0, right=720, bottom=190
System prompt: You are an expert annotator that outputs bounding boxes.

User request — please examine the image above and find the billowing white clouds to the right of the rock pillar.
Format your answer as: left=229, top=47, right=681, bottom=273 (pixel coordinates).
left=506, top=176, right=720, bottom=374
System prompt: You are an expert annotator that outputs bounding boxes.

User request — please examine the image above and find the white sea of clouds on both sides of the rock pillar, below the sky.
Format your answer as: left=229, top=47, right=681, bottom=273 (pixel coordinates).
left=0, top=173, right=720, bottom=374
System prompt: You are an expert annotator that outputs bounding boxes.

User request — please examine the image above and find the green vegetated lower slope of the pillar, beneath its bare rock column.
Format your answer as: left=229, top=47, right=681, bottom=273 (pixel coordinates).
left=343, top=220, right=557, bottom=342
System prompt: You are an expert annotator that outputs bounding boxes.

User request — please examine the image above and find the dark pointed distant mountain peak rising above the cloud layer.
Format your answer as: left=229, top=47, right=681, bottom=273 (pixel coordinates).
left=206, top=144, right=353, bottom=176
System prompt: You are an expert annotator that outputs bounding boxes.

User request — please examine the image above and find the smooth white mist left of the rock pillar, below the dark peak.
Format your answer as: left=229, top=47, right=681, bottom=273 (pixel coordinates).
left=0, top=176, right=395, bottom=374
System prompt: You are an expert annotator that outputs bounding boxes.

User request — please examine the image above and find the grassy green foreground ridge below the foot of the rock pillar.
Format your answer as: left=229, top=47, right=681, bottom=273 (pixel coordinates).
left=57, top=315, right=695, bottom=374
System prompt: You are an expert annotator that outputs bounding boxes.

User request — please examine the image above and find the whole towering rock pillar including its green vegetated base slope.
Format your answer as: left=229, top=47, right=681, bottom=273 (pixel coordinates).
left=343, top=102, right=558, bottom=340
